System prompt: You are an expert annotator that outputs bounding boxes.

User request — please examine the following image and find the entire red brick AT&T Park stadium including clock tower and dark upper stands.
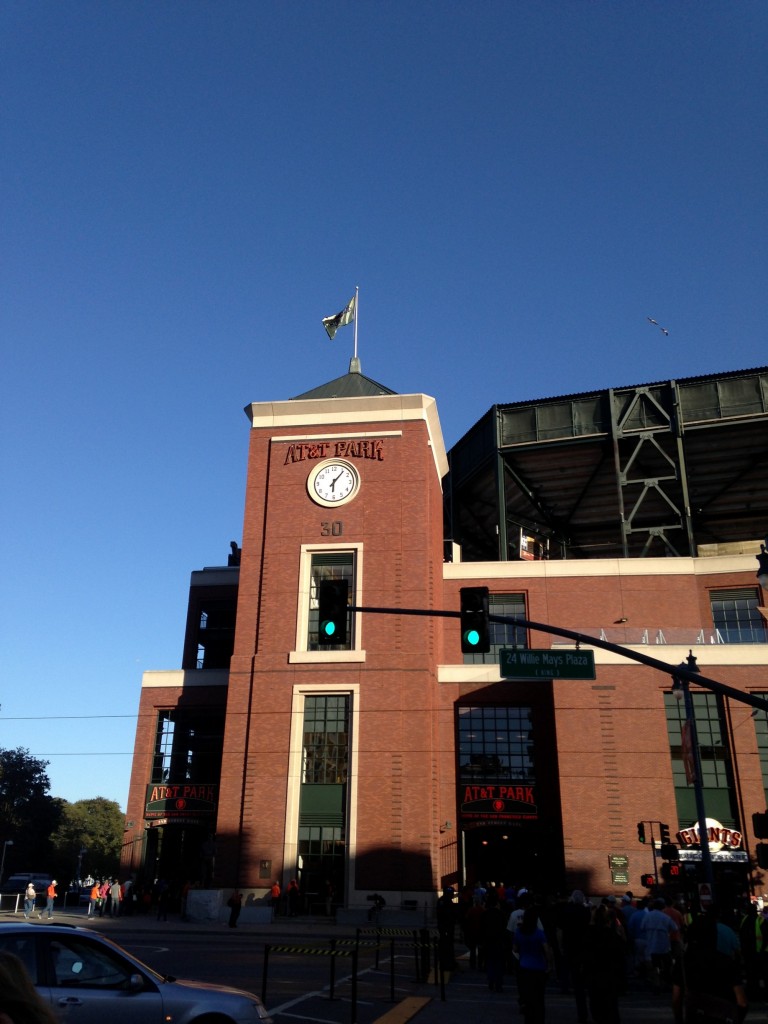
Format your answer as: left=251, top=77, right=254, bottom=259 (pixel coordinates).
left=123, top=359, right=768, bottom=907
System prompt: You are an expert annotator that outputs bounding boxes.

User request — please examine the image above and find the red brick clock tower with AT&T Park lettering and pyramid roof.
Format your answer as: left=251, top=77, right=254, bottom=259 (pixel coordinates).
left=217, top=359, right=455, bottom=904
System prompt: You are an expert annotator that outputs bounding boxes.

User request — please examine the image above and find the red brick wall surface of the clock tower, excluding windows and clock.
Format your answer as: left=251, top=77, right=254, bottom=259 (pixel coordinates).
left=217, top=411, right=442, bottom=888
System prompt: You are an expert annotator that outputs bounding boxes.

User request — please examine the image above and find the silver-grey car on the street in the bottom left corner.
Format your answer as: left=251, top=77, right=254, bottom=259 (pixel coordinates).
left=0, top=922, right=272, bottom=1024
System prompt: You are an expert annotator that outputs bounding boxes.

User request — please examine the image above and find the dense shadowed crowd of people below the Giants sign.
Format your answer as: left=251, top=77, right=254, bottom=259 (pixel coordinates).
left=436, top=883, right=768, bottom=1024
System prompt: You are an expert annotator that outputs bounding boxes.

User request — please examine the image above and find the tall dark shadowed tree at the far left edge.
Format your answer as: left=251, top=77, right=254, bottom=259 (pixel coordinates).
left=0, top=746, right=61, bottom=874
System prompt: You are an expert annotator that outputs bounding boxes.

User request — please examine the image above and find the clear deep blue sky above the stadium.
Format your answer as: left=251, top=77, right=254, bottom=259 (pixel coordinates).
left=0, top=0, right=768, bottom=815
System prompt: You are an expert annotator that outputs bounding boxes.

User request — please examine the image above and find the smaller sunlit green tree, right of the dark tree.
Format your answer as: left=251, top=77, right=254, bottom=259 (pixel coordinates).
left=51, top=797, right=123, bottom=879
